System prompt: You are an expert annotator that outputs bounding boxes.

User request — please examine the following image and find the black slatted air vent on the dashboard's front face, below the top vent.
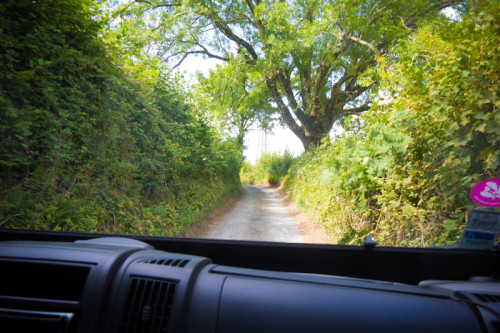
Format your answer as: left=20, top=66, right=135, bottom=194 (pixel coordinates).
left=121, top=278, right=175, bottom=333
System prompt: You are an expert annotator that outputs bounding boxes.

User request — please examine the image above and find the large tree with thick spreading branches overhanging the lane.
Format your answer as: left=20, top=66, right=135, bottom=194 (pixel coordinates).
left=116, top=0, right=455, bottom=150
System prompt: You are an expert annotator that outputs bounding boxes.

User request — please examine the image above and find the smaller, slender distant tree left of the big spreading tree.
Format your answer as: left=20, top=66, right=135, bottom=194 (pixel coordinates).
left=197, top=61, right=277, bottom=150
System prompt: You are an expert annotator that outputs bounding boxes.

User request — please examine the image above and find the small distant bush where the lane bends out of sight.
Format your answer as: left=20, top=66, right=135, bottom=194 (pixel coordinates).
left=240, top=150, right=294, bottom=186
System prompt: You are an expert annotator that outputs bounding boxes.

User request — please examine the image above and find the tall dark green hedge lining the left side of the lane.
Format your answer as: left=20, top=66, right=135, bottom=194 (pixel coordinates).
left=0, top=0, right=240, bottom=236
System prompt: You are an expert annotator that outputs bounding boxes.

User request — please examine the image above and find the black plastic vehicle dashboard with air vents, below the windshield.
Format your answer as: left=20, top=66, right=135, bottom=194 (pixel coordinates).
left=0, top=233, right=500, bottom=333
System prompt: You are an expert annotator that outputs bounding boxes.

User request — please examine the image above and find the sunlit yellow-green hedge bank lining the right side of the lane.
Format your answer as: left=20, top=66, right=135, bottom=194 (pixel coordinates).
left=285, top=0, right=500, bottom=246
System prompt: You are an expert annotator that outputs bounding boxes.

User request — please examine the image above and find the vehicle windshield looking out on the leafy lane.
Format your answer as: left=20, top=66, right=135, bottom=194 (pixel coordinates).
left=0, top=0, right=500, bottom=247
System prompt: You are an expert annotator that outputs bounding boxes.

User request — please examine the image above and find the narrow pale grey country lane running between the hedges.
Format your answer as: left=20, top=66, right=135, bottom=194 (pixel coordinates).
left=209, top=186, right=304, bottom=243
